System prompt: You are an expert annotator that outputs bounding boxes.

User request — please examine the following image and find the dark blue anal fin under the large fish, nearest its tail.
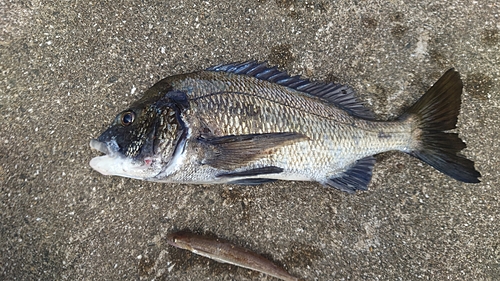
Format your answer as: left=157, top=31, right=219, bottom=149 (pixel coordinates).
left=325, top=156, right=375, bottom=193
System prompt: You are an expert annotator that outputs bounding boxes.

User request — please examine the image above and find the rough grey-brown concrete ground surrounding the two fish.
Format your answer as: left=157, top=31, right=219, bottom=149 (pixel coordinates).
left=0, top=0, right=500, bottom=280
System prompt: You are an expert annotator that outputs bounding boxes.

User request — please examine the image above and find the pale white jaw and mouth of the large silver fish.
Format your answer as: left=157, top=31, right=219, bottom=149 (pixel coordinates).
left=89, top=139, right=161, bottom=179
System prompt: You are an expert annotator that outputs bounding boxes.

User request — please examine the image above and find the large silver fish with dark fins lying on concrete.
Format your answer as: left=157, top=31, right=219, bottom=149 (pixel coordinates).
left=90, top=61, right=481, bottom=193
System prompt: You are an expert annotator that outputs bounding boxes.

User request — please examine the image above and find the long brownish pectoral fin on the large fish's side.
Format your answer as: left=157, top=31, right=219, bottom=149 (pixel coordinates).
left=198, top=132, right=309, bottom=170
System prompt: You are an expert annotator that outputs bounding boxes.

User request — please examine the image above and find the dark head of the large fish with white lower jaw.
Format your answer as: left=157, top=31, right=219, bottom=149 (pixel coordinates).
left=90, top=93, right=187, bottom=180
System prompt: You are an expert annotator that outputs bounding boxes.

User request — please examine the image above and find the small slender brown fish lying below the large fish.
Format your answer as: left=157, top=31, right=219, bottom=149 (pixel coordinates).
left=167, top=231, right=299, bottom=281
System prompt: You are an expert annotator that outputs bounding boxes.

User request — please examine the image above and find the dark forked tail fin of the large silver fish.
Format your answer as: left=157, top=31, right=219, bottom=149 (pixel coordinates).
left=399, top=68, right=481, bottom=183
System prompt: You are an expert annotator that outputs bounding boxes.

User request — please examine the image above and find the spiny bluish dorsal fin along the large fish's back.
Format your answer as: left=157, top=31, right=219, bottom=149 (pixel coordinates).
left=207, top=61, right=374, bottom=119
